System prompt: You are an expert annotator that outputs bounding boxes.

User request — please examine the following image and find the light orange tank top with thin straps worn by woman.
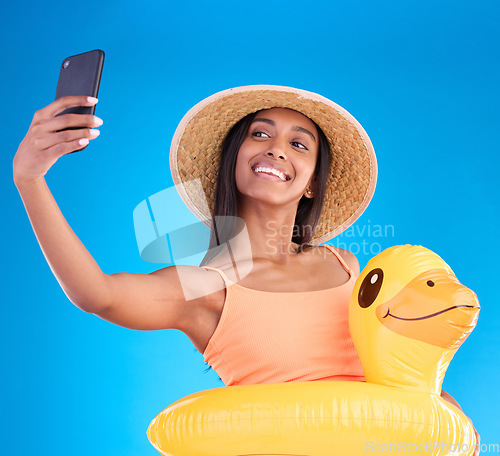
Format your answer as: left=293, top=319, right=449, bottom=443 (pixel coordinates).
left=203, top=244, right=365, bottom=386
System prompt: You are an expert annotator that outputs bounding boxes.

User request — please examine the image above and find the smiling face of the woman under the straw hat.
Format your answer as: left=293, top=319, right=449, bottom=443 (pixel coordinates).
left=236, top=108, right=318, bottom=210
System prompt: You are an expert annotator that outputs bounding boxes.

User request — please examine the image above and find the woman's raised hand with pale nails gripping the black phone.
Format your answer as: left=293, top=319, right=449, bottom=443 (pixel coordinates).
left=12, top=95, right=102, bottom=182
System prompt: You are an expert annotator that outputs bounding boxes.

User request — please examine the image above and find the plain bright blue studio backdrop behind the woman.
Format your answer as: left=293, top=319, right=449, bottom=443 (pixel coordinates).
left=0, top=0, right=500, bottom=456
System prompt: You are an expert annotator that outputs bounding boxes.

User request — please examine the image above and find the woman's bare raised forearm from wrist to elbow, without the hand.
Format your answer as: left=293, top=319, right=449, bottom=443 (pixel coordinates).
left=15, top=177, right=107, bottom=312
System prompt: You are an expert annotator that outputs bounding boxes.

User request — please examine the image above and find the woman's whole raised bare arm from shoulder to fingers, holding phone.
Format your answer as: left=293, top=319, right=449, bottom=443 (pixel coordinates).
left=13, top=97, right=225, bottom=329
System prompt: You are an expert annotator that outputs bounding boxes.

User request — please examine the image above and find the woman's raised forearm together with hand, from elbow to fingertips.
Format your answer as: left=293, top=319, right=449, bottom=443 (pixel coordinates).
left=12, top=96, right=105, bottom=311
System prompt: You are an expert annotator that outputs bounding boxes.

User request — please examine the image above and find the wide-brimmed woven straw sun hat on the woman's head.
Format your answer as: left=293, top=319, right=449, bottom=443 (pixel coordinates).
left=170, top=85, right=377, bottom=245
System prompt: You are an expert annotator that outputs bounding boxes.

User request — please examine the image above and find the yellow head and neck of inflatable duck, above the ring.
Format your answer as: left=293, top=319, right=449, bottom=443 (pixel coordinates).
left=349, top=245, right=480, bottom=394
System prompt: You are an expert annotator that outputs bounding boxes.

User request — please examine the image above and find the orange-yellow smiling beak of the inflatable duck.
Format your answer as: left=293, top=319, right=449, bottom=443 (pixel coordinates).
left=375, top=269, right=480, bottom=349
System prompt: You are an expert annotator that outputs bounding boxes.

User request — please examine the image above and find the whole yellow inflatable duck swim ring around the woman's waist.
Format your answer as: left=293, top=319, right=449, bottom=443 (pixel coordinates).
left=147, top=245, right=479, bottom=456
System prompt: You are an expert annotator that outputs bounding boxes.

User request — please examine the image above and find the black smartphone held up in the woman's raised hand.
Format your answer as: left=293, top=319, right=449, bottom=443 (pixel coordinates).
left=55, top=49, right=104, bottom=152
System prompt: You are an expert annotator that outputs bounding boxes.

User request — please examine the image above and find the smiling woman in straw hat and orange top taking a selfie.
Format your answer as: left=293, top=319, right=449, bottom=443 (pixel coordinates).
left=13, top=86, right=480, bottom=450
